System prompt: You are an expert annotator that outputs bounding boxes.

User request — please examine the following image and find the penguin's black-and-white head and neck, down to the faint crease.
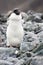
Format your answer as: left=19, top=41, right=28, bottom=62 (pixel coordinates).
left=9, top=8, right=22, bottom=20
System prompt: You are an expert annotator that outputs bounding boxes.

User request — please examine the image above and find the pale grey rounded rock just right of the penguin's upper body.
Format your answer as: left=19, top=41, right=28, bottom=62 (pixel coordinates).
left=24, top=20, right=37, bottom=32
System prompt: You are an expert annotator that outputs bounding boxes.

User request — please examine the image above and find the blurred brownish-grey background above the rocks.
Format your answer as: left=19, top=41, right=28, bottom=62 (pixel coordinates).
left=0, top=0, right=43, bottom=13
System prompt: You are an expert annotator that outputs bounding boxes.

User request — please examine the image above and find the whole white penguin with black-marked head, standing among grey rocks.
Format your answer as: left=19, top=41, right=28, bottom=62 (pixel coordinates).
left=6, top=9, right=24, bottom=47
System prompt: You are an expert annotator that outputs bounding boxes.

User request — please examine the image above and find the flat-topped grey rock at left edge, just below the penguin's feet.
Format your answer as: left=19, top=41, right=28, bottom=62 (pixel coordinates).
left=0, top=47, right=17, bottom=60
